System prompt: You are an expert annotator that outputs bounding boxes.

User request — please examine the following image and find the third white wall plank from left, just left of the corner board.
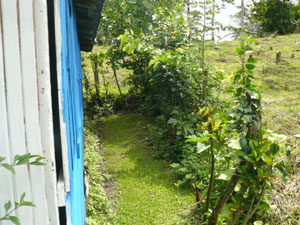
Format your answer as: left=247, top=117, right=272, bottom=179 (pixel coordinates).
left=19, top=0, right=48, bottom=225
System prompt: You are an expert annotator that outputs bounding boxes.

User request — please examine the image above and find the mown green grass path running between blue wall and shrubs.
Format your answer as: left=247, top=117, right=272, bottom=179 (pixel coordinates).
left=99, top=114, right=195, bottom=225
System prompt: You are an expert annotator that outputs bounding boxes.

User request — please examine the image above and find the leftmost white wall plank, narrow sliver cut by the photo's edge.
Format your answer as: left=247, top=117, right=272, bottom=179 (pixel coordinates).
left=0, top=2, right=14, bottom=225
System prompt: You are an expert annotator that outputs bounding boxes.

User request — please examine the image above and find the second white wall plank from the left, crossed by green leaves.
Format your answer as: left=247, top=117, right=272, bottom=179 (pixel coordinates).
left=1, top=0, right=33, bottom=224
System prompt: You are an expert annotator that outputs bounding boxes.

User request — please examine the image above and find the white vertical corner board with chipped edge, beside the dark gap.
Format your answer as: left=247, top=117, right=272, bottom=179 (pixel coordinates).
left=33, top=0, right=59, bottom=225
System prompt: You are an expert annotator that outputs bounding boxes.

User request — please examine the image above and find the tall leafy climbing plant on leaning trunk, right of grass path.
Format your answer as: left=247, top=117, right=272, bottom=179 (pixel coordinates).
left=208, top=37, right=287, bottom=225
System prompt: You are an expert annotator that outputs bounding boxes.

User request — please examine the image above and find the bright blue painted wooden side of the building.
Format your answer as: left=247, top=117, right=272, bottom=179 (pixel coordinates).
left=60, top=0, right=86, bottom=225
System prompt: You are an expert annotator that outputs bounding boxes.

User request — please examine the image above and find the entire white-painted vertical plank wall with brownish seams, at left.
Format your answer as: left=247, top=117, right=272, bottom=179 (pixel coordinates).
left=0, top=0, right=59, bottom=225
